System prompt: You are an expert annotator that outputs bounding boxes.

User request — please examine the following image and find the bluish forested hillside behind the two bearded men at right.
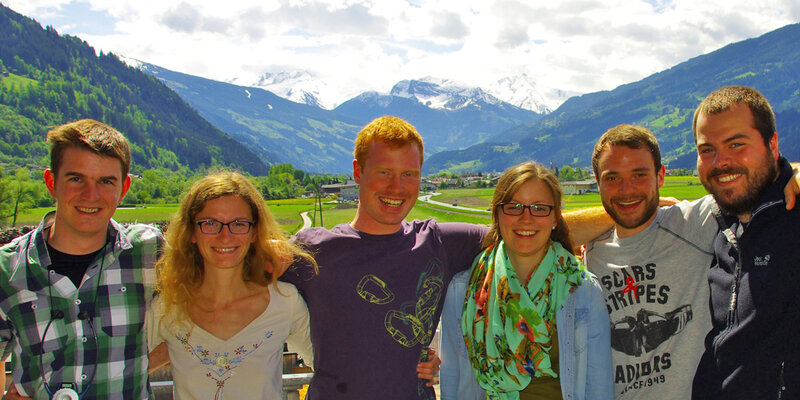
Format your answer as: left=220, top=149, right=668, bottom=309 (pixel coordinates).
left=425, top=24, right=800, bottom=173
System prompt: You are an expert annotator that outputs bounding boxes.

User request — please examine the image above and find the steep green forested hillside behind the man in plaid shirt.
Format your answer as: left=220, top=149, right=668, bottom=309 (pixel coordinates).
left=0, top=5, right=268, bottom=175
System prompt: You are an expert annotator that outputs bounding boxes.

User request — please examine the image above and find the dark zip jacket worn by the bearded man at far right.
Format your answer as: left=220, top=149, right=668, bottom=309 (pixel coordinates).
left=692, top=157, right=800, bottom=400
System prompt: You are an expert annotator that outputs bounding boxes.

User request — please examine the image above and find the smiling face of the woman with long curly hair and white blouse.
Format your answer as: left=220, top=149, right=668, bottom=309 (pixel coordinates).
left=192, top=195, right=255, bottom=269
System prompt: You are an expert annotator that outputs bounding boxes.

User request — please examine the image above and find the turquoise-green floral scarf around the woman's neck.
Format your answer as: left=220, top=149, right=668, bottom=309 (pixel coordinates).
left=461, top=241, right=586, bottom=400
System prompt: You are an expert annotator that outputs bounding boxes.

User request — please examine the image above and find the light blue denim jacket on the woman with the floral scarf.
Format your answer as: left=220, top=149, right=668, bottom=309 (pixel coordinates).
left=439, top=270, right=614, bottom=400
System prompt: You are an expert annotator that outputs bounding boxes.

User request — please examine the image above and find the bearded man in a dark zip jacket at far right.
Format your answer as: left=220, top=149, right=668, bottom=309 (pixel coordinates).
left=692, top=86, right=800, bottom=399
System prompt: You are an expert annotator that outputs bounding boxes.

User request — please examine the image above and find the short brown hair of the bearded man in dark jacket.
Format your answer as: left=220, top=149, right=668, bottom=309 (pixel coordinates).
left=692, top=86, right=778, bottom=146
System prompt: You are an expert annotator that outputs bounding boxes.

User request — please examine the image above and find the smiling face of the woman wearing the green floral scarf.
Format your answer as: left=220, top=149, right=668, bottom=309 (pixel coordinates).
left=495, top=178, right=560, bottom=270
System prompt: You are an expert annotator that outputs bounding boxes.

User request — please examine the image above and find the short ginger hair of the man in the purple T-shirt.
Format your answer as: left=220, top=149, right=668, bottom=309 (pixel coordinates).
left=353, top=116, right=425, bottom=167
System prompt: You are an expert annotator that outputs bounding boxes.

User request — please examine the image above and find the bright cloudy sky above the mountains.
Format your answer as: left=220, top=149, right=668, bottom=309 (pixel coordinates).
left=3, top=0, right=800, bottom=106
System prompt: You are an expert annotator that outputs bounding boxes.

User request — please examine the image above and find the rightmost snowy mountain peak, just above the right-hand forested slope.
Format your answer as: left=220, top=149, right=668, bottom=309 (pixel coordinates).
left=486, top=74, right=580, bottom=114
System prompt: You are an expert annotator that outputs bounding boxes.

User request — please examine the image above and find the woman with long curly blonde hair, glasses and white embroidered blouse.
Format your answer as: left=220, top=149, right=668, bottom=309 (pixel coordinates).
left=147, top=172, right=316, bottom=399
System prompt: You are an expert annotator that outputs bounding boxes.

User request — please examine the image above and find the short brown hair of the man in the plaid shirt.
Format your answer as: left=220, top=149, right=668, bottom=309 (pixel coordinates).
left=47, top=119, right=131, bottom=179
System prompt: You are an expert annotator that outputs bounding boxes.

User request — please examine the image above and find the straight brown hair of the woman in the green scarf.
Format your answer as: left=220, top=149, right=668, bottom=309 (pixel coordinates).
left=483, top=161, right=574, bottom=253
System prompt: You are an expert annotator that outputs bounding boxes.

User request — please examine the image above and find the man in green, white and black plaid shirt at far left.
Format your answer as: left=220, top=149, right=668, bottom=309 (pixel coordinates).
left=0, top=120, right=163, bottom=399
